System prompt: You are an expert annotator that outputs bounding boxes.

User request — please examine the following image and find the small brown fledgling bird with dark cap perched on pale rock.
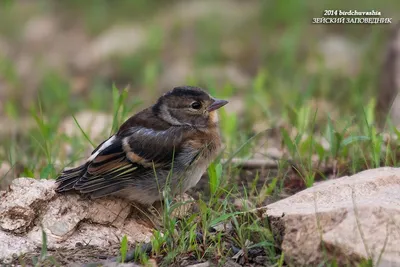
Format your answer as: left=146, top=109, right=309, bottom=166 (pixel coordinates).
left=56, top=86, right=228, bottom=205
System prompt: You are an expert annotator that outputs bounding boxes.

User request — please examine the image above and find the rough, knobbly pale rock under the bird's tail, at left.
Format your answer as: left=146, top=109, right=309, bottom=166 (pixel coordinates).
left=0, top=178, right=152, bottom=263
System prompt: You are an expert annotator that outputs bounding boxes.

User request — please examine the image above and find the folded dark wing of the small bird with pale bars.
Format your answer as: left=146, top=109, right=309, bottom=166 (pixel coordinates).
left=74, top=127, right=191, bottom=197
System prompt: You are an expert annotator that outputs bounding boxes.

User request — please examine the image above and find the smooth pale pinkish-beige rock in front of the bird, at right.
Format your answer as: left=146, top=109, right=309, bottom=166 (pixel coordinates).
left=264, top=167, right=400, bottom=266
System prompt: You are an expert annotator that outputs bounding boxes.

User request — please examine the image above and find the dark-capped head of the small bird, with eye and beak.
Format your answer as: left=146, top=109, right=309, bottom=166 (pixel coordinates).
left=153, top=86, right=228, bottom=128
